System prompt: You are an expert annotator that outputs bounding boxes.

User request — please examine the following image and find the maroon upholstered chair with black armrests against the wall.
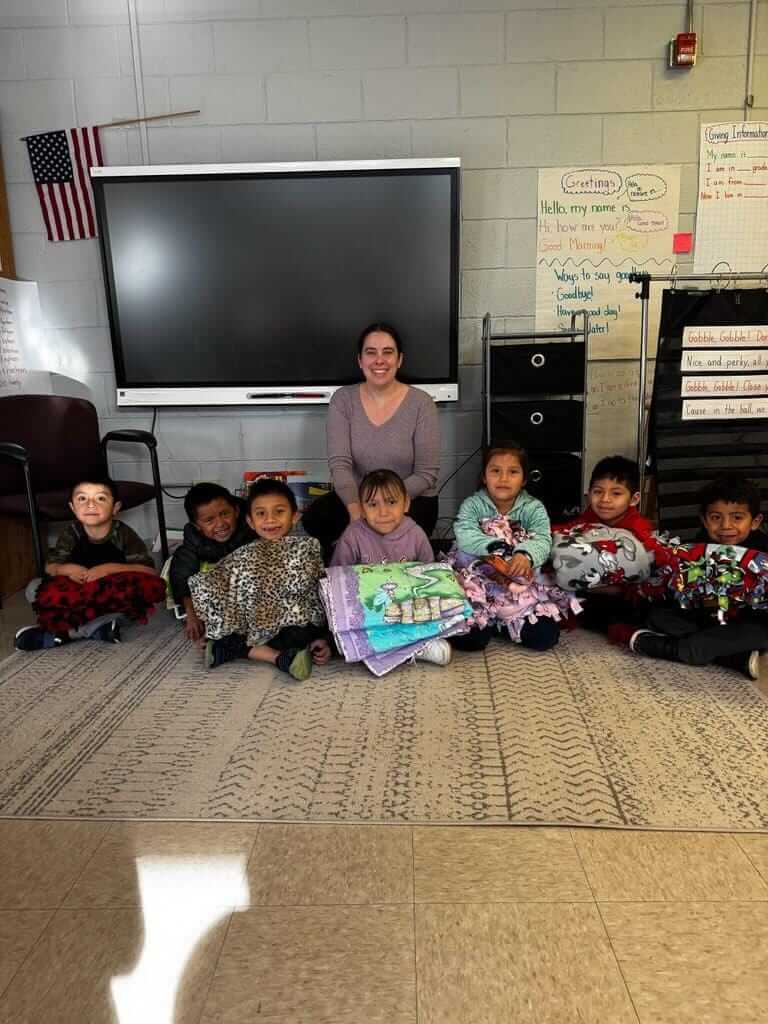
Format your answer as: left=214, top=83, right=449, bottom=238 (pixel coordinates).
left=0, top=394, right=168, bottom=575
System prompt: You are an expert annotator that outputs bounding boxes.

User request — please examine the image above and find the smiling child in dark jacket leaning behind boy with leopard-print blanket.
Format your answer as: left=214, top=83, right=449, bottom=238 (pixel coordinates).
left=170, top=483, right=256, bottom=643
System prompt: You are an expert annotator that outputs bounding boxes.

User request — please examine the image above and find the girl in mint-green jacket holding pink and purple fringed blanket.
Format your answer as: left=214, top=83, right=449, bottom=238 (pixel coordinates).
left=450, top=443, right=580, bottom=650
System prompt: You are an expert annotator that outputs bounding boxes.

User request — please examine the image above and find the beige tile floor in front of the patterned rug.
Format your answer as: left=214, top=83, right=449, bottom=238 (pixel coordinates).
left=0, top=601, right=768, bottom=1024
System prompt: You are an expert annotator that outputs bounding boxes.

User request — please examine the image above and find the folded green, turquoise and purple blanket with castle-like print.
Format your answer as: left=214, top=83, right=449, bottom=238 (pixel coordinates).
left=321, top=562, right=472, bottom=676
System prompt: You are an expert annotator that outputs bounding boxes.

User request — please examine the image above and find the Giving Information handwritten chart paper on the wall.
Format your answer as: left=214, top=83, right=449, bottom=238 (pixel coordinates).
left=693, top=121, right=768, bottom=273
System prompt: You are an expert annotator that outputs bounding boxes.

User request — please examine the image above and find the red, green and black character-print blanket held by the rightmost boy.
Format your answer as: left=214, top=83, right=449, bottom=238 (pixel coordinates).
left=638, top=543, right=768, bottom=622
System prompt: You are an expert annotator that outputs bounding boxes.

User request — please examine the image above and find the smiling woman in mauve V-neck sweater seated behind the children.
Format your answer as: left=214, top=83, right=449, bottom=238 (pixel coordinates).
left=303, top=324, right=440, bottom=555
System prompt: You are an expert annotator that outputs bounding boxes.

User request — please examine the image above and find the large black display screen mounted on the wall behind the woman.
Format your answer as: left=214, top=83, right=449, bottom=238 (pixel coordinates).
left=94, top=168, right=459, bottom=387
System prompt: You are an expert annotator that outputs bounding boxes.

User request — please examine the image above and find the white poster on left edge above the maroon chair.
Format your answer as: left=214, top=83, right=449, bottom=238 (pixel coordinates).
left=0, top=278, right=42, bottom=396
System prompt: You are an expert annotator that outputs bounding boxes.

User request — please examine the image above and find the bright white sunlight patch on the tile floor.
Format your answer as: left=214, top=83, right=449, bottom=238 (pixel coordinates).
left=110, top=855, right=250, bottom=1024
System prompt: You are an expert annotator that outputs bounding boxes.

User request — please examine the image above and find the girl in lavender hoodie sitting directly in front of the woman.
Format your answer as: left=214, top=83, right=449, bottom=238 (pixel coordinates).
left=331, top=469, right=452, bottom=665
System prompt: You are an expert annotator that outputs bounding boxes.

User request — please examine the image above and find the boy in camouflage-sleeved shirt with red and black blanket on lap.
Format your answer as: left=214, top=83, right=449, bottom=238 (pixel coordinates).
left=15, top=476, right=165, bottom=650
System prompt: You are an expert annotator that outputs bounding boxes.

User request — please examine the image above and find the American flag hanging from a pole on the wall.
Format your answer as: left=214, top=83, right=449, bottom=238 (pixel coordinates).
left=26, top=126, right=103, bottom=242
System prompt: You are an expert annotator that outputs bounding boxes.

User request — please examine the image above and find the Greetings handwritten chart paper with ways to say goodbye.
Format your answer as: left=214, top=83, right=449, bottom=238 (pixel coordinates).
left=536, top=166, right=680, bottom=359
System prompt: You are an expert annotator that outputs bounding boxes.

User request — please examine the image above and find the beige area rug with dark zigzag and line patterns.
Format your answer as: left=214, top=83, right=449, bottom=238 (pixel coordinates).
left=0, top=617, right=768, bottom=830
